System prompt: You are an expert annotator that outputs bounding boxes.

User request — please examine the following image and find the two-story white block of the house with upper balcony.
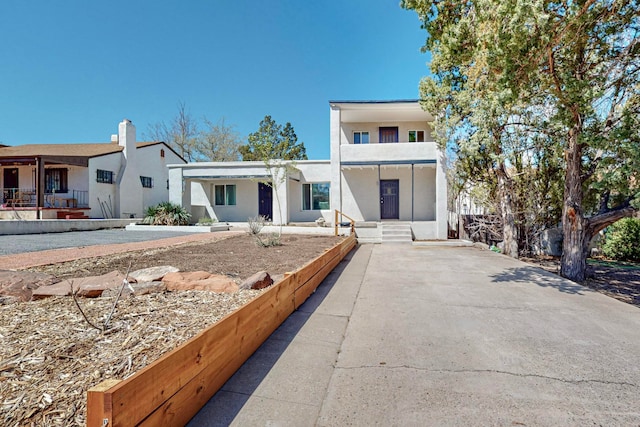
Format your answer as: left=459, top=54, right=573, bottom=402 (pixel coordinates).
left=329, top=100, right=447, bottom=240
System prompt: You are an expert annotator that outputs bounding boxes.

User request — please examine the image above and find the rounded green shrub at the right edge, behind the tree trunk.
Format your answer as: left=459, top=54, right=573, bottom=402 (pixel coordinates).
left=602, top=218, right=640, bottom=262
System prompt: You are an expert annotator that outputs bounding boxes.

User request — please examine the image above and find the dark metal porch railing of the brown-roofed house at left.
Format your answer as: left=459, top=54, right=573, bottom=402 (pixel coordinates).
left=0, top=188, right=89, bottom=208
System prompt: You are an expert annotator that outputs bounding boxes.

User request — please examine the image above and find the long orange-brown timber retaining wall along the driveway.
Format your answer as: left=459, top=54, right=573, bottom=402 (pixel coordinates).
left=87, top=234, right=356, bottom=427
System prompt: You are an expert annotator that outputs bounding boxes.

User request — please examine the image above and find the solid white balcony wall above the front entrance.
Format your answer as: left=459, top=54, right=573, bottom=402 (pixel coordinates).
left=340, top=141, right=438, bottom=165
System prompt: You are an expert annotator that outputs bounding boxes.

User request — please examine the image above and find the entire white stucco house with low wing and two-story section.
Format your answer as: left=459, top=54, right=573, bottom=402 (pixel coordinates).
left=168, top=100, right=447, bottom=240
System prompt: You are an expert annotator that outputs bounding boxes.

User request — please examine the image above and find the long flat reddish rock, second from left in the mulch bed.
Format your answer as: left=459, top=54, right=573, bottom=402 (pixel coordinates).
left=33, top=271, right=124, bottom=300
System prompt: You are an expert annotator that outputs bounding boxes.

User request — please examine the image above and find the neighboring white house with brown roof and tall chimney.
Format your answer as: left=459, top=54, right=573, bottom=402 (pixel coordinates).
left=0, top=120, right=186, bottom=219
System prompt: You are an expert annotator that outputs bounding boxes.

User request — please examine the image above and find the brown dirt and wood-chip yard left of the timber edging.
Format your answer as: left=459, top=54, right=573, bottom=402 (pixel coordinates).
left=0, top=235, right=342, bottom=426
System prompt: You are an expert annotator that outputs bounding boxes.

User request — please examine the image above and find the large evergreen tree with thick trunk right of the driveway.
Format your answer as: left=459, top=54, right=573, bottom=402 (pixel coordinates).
left=402, top=0, right=640, bottom=281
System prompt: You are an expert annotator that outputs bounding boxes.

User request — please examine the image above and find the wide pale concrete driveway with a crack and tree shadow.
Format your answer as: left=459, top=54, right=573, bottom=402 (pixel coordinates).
left=189, top=245, right=640, bottom=427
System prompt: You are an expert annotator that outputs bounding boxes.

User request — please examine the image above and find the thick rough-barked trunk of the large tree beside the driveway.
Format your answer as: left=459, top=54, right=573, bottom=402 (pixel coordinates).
left=560, top=125, right=591, bottom=282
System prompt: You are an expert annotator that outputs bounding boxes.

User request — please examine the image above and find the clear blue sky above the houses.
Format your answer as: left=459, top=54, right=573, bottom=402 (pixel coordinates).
left=0, top=0, right=429, bottom=159
